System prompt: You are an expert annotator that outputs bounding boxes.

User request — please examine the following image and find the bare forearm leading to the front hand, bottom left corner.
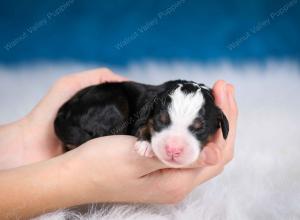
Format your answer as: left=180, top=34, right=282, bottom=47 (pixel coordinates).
left=0, top=154, right=82, bottom=219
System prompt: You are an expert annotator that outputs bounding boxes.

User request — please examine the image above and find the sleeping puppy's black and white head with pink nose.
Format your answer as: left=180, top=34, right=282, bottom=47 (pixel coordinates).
left=150, top=81, right=229, bottom=167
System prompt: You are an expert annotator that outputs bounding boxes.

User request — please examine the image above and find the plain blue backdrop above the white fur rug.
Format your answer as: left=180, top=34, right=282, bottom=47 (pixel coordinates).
left=0, top=0, right=300, bottom=65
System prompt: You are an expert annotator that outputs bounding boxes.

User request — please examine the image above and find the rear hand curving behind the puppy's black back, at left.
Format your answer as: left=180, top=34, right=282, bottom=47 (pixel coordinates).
left=3, top=68, right=126, bottom=167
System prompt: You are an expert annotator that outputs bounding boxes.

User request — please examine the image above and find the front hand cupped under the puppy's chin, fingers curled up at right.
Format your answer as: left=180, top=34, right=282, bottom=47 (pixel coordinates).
left=64, top=81, right=237, bottom=203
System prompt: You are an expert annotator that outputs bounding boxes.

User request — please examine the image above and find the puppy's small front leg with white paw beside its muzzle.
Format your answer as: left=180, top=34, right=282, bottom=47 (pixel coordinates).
left=134, top=125, right=154, bottom=157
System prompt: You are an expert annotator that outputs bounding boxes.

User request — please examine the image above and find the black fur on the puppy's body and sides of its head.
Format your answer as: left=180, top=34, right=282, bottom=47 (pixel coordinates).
left=54, top=80, right=229, bottom=150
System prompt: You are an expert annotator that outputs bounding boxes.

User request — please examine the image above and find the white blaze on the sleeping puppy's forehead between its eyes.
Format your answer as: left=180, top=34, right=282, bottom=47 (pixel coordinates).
left=168, top=85, right=204, bottom=126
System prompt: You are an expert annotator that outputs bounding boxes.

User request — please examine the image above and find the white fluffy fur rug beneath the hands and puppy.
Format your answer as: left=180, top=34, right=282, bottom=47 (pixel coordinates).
left=0, top=61, right=300, bottom=220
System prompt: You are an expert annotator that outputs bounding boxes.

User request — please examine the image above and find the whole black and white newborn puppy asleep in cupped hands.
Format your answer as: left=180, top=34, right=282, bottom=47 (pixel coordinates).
left=54, top=80, right=229, bottom=167
